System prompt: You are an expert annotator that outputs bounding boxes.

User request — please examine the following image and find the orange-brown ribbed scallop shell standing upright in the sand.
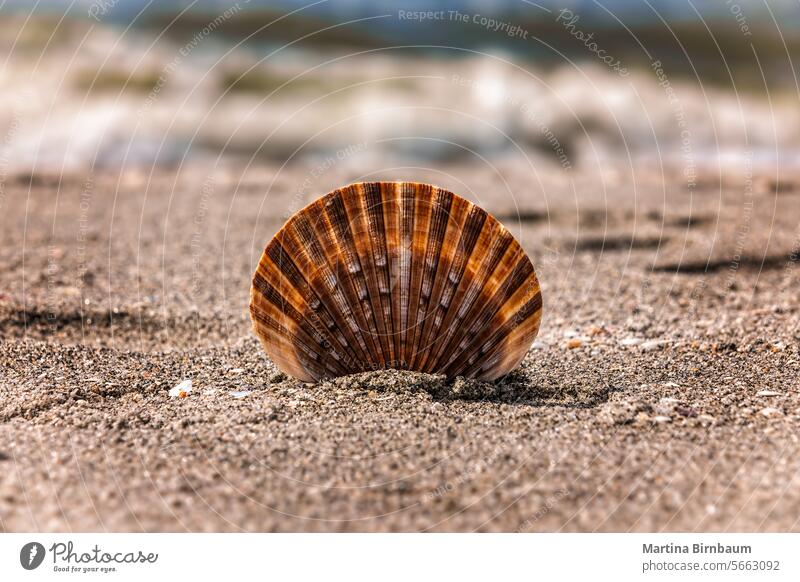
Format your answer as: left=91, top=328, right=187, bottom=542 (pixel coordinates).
left=250, top=182, right=542, bottom=382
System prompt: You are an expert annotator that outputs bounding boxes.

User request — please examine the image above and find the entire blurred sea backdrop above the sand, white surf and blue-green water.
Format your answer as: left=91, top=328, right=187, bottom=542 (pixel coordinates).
left=0, top=0, right=800, bottom=179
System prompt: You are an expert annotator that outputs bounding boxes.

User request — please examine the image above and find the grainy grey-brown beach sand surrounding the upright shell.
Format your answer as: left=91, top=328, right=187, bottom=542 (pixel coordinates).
left=0, top=166, right=800, bottom=531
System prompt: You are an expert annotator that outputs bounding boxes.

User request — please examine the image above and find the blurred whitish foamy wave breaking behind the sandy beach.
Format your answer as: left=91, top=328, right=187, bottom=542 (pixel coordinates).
left=0, top=19, right=800, bottom=178
